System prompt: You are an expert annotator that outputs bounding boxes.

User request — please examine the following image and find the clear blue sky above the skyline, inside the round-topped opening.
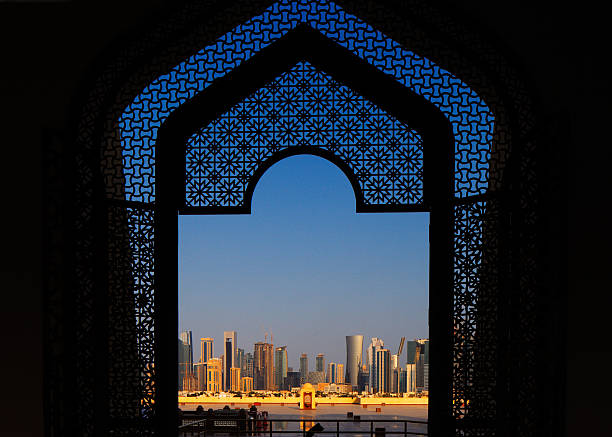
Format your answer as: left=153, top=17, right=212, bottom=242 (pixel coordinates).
left=179, top=156, right=429, bottom=370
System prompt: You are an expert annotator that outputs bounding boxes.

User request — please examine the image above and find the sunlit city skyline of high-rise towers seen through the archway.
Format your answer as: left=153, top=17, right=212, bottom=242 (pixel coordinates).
left=178, top=331, right=429, bottom=394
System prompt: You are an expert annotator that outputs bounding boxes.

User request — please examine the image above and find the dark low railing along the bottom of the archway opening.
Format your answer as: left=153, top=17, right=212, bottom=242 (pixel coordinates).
left=179, top=416, right=427, bottom=437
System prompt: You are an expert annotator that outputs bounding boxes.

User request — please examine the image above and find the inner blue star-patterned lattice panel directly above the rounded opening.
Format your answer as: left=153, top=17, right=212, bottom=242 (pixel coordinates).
left=185, top=62, right=423, bottom=207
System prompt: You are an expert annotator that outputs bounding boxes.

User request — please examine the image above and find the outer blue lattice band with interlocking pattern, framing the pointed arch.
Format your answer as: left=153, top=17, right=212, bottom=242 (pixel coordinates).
left=119, top=0, right=495, bottom=202
